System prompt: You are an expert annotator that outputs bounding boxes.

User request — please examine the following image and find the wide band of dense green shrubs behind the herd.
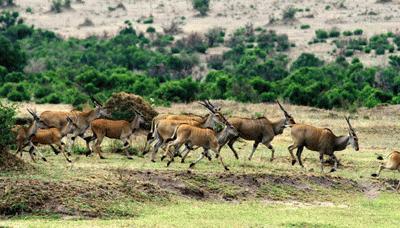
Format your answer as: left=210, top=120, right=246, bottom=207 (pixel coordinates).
left=0, top=11, right=400, bottom=109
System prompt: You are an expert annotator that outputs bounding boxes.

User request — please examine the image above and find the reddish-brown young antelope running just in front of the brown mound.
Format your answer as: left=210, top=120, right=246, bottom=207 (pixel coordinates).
left=85, top=111, right=145, bottom=159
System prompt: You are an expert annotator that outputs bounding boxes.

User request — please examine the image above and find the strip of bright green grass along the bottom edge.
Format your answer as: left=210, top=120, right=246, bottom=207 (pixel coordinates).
left=0, top=194, right=400, bottom=227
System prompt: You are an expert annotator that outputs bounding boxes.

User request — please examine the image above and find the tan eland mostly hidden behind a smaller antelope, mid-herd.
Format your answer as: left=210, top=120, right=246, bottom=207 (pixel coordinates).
left=151, top=100, right=223, bottom=162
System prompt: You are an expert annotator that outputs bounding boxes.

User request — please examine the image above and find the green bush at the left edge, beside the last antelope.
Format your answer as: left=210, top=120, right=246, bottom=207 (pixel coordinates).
left=0, top=103, right=16, bottom=153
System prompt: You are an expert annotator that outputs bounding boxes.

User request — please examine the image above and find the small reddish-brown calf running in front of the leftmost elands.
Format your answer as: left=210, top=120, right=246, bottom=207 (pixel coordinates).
left=29, top=116, right=78, bottom=162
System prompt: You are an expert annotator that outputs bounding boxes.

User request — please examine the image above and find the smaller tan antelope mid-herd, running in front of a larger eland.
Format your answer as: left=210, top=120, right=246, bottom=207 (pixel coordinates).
left=166, top=104, right=239, bottom=170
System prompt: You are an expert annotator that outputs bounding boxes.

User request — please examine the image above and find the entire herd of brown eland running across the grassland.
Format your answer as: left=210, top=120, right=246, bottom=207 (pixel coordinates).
left=12, top=97, right=400, bottom=189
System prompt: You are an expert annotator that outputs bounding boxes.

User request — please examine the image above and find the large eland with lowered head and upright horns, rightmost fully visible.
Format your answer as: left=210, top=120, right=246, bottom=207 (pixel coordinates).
left=288, top=117, right=359, bottom=172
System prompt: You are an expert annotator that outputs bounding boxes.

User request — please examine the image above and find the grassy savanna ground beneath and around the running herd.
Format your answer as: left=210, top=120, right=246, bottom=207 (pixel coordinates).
left=0, top=101, right=400, bottom=227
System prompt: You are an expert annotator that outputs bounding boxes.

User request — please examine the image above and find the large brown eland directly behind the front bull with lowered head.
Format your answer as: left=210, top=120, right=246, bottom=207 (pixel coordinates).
left=228, top=101, right=295, bottom=161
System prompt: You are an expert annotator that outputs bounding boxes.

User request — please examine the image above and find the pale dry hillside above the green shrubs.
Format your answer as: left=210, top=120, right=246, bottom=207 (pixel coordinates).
left=6, top=0, right=400, bottom=66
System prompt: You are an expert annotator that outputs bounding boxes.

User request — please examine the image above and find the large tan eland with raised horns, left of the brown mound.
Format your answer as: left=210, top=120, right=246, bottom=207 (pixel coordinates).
left=40, top=97, right=109, bottom=149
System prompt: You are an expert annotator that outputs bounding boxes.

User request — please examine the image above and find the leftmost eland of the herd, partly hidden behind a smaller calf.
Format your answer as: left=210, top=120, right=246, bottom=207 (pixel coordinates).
left=12, top=108, right=46, bottom=161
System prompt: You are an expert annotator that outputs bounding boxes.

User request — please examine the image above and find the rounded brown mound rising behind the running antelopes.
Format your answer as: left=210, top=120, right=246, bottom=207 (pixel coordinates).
left=105, top=92, right=158, bottom=129
